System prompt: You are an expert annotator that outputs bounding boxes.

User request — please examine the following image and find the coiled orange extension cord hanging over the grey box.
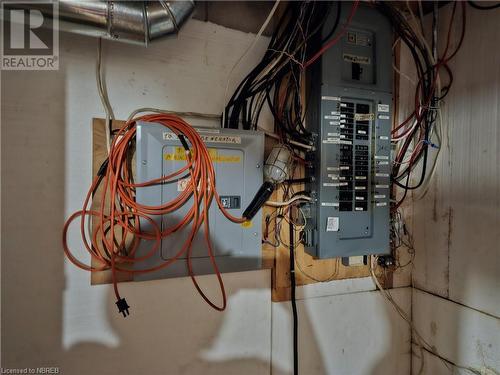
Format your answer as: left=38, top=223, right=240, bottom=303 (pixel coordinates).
left=62, top=114, right=245, bottom=311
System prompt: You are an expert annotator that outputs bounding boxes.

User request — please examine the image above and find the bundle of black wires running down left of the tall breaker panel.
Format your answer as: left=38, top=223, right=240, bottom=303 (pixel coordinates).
left=224, top=1, right=340, bottom=148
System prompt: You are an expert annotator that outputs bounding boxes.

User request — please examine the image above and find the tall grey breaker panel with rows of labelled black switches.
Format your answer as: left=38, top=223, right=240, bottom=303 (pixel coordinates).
left=304, top=2, right=392, bottom=258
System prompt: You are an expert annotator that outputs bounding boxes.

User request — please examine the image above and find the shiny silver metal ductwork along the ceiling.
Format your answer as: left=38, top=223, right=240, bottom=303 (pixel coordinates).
left=29, top=0, right=194, bottom=46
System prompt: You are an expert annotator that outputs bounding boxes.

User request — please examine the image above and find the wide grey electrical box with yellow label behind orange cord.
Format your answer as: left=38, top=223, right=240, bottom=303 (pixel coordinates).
left=135, top=122, right=264, bottom=280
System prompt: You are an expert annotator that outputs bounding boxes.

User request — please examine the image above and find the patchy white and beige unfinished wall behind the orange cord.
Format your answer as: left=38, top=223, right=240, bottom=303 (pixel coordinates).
left=1, top=20, right=410, bottom=375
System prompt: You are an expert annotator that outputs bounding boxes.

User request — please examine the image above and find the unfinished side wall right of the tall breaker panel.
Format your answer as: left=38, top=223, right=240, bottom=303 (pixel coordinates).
left=401, top=4, right=500, bottom=375
